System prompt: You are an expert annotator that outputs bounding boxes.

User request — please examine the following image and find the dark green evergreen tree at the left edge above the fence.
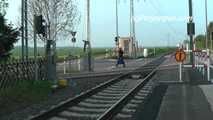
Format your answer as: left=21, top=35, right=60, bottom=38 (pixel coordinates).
left=0, top=14, right=19, bottom=58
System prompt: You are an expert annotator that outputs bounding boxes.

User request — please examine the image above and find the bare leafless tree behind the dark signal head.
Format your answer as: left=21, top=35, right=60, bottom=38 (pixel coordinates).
left=28, top=0, right=80, bottom=40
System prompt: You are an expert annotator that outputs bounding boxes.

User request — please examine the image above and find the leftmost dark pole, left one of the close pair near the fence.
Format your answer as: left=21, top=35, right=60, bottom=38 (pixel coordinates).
left=21, top=0, right=25, bottom=60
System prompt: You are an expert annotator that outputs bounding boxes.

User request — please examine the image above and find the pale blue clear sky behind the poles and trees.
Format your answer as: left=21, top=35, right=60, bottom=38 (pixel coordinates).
left=6, top=0, right=213, bottom=47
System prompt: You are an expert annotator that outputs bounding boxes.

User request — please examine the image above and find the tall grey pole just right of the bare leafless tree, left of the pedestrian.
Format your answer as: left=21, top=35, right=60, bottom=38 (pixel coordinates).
left=86, top=0, right=92, bottom=71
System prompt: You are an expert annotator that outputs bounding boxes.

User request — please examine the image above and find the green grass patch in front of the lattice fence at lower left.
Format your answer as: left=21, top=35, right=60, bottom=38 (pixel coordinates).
left=0, top=81, right=51, bottom=103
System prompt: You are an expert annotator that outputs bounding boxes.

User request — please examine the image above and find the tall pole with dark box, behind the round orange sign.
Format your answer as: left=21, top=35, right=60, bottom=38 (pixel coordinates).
left=188, top=0, right=194, bottom=64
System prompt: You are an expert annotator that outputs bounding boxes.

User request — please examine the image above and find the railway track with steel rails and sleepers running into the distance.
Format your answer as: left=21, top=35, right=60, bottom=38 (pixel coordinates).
left=29, top=57, right=165, bottom=120
